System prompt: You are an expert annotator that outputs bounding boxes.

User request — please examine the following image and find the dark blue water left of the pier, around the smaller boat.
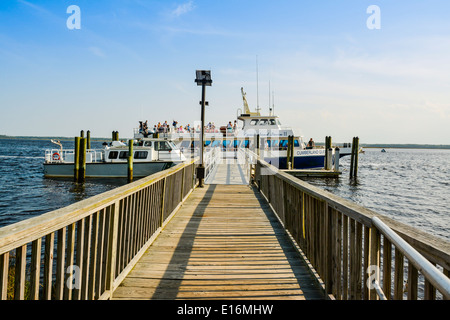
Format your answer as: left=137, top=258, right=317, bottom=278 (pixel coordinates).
left=0, top=139, right=126, bottom=227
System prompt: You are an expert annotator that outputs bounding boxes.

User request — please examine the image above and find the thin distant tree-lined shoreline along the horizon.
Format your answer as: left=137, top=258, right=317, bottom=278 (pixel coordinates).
left=0, top=135, right=450, bottom=149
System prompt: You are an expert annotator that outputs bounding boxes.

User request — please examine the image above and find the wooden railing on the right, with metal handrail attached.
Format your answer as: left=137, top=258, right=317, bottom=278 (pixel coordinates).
left=254, top=160, right=450, bottom=300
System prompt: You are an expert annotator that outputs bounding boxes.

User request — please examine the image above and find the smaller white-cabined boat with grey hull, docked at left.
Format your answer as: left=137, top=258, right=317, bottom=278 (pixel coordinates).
left=44, top=138, right=186, bottom=178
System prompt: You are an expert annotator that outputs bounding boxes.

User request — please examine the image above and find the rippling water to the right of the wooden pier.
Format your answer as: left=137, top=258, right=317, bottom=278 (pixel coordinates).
left=304, top=148, right=450, bottom=241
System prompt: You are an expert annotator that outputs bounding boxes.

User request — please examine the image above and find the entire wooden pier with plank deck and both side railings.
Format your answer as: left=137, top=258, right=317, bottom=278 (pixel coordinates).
left=0, top=150, right=450, bottom=300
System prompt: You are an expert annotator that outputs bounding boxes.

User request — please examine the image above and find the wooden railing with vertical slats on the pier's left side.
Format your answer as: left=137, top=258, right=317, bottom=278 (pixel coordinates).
left=0, top=161, right=195, bottom=300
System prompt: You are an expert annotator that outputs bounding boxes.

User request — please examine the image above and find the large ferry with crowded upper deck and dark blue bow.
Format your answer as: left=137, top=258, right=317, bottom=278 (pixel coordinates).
left=134, top=88, right=351, bottom=169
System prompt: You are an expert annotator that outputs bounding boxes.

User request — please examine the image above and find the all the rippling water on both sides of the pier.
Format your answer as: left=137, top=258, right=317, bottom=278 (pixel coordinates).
left=0, top=139, right=450, bottom=241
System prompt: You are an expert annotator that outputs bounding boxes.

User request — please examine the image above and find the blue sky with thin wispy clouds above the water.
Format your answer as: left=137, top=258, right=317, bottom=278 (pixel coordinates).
left=0, top=0, right=450, bottom=144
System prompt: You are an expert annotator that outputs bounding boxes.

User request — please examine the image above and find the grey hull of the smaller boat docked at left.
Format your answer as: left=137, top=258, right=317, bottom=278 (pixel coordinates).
left=44, top=161, right=178, bottom=178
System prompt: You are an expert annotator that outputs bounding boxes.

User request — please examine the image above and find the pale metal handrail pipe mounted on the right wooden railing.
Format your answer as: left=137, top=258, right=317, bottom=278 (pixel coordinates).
left=372, top=217, right=450, bottom=299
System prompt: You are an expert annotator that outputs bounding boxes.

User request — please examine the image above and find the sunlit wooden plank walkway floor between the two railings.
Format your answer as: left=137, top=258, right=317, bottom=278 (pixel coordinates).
left=113, top=185, right=323, bottom=300
